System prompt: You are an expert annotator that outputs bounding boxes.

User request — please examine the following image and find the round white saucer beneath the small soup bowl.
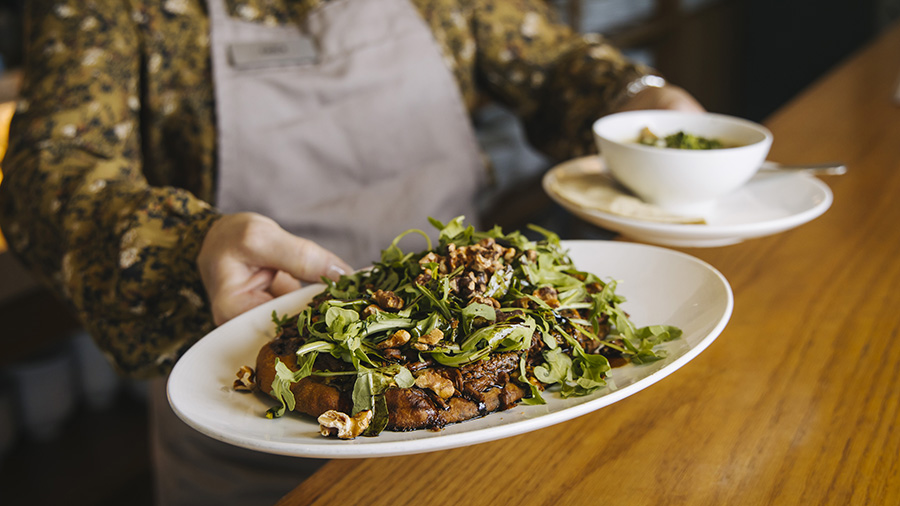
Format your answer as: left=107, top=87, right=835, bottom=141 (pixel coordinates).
left=543, top=156, right=834, bottom=247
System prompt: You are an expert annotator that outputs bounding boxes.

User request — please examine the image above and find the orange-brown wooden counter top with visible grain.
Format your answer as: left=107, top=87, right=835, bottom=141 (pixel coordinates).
left=279, top=21, right=900, bottom=506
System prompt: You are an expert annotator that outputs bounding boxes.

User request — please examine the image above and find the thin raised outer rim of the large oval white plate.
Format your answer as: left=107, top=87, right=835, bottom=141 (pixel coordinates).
left=166, top=240, right=734, bottom=459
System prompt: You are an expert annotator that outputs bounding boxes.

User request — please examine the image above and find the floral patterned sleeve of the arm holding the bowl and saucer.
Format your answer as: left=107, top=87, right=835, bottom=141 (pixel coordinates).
left=473, top=0, right=651, bottom=159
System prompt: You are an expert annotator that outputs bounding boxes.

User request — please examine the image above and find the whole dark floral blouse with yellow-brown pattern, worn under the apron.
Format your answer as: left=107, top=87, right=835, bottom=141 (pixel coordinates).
left=0, top=0, right=648, bottom=377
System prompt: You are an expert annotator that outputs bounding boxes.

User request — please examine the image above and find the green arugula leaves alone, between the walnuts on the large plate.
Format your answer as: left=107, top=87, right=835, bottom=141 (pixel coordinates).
left=267, top=217, right=681, bottom=435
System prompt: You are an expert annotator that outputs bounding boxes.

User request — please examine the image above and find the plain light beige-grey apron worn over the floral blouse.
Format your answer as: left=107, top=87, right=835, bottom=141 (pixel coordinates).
left=156, top=0, right=492, bottom=506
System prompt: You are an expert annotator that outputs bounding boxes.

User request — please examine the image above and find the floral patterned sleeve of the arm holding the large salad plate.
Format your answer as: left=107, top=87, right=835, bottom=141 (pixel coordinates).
left=0, top=0, right=217, bottom=377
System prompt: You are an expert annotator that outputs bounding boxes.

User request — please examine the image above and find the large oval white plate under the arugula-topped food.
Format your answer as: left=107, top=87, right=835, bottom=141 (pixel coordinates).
left=168, top=241, right=733, bottom=458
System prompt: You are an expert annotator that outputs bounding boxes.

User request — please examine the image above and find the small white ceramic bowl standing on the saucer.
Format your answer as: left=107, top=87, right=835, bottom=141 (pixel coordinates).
left=594, top=110, right=772, bottom=215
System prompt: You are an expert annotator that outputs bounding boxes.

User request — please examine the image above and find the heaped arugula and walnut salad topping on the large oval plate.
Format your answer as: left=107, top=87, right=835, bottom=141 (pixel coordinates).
left=266, top=217, right=681, bottom=435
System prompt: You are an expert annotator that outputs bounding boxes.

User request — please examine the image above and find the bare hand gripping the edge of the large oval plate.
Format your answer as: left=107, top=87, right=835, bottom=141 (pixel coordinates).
left=197, top=213, right=351, bottom=325
